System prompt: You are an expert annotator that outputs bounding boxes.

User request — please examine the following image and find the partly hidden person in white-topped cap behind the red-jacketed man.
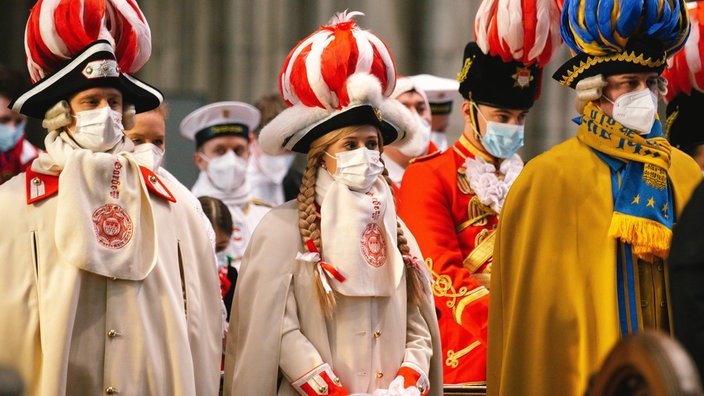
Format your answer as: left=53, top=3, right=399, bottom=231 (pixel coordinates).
left=410, top=74, right=460, bottom=151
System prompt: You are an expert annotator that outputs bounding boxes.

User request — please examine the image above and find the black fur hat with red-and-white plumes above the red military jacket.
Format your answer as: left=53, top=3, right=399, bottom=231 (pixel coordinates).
left=457, top=0, right=561, bottom=109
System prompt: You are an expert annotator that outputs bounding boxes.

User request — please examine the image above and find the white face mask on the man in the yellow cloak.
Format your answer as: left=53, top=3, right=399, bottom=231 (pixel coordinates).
left=604, top=88, right=658, bottom=135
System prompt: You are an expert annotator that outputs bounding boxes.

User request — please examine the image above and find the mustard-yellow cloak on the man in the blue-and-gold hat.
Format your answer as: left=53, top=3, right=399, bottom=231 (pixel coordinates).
left=487, top=137, right=702, bottom=396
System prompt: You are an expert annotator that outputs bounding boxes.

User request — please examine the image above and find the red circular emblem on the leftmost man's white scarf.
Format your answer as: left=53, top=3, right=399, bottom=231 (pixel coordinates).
left=93, top=204, right=134, bottom=249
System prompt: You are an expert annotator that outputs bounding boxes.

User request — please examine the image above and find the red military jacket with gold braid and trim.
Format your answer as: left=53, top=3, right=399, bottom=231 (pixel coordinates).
left=397, top=135, right=498, bottom=384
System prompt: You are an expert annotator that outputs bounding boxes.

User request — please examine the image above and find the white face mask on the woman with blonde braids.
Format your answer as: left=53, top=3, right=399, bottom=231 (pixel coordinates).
left=325, top=147, right=384, bottom=192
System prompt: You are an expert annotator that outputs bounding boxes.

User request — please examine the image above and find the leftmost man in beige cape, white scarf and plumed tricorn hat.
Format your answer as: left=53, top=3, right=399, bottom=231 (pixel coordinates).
left=0, top=0, right=222, bottom=396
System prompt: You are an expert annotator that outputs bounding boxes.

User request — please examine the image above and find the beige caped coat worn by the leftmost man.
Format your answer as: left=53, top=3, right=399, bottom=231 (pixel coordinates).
left=0, top=168, right=222, bottom=396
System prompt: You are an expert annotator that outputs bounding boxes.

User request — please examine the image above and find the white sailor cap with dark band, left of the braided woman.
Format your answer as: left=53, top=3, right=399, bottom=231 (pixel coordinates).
left=180, top=101, right=261, bottom=148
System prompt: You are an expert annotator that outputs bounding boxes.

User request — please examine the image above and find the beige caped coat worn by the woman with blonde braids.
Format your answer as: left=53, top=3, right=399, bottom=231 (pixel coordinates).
left=224, top=201, right=442, bottom=395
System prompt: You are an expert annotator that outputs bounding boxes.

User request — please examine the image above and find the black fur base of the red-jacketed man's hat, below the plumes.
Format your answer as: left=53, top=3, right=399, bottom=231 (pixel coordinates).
left=457, top=42, right=543, bottom=109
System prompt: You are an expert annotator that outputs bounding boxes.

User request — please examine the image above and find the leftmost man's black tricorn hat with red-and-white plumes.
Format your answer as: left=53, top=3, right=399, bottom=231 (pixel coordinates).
left=12, top=0, right=163, bottom=118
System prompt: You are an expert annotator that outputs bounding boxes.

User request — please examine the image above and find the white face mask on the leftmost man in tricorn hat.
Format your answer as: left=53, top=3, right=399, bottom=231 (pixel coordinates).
left=71, top=106, right=124, bottom=153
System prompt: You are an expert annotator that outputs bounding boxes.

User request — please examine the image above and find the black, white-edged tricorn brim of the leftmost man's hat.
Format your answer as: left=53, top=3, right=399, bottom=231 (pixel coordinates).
left=10, top=40, right=164, bottom=119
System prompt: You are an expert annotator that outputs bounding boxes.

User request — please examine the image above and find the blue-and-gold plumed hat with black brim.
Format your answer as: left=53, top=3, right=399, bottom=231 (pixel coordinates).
left=553, top=0, right=690, bottom=88
